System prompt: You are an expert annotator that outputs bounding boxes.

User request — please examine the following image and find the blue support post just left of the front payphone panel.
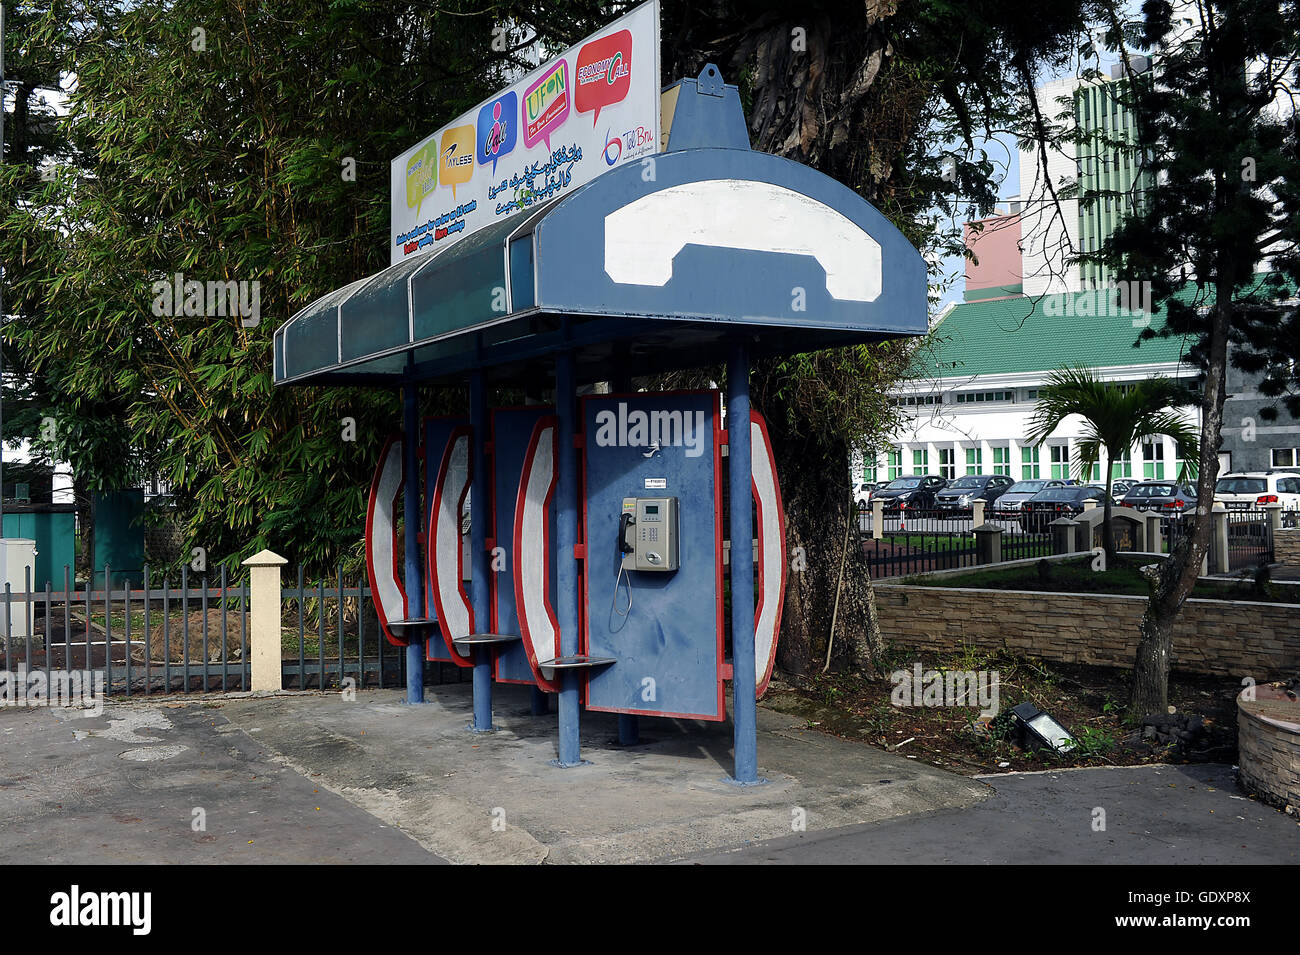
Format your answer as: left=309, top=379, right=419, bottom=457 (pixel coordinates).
left=555, top=352, right=582, bottom=769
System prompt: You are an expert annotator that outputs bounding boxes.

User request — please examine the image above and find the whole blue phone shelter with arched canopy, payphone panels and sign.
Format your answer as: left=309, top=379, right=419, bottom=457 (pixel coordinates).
left=274, top=50, right=928, bottom=785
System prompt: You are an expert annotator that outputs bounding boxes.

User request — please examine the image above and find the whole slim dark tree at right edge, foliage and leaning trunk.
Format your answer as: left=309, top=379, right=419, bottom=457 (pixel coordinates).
left=1099, top=0, right=1300, bottom=716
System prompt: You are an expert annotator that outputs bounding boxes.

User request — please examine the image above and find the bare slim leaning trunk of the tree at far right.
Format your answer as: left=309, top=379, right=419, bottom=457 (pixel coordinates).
left=1128, top=289, right=1232, bottom=719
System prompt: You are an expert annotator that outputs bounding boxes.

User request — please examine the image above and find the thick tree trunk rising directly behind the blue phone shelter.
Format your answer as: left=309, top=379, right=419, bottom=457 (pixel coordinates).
left=702, top=9, right=904, bottom=674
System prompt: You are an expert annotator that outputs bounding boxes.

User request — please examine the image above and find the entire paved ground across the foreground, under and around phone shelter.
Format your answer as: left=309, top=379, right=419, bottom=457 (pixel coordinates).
left=0, top=685, right=1300, bottom=864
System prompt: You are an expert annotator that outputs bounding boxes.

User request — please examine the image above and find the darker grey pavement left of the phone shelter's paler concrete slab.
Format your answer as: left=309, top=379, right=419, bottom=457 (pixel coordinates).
left=0, top=703, right=438, bottom=865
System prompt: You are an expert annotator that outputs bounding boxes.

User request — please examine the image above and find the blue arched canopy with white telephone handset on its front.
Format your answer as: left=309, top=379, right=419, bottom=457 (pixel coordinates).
left=274, top=148, right=927, bottom=386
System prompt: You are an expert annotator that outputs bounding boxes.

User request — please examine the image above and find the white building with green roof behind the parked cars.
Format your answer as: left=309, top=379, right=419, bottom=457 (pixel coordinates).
left=862, top=288, right=1199, bottom=481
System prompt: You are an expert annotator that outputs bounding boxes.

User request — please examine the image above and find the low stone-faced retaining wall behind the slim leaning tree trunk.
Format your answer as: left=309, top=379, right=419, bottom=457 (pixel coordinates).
left=876, top=583, right=1300, bottom=683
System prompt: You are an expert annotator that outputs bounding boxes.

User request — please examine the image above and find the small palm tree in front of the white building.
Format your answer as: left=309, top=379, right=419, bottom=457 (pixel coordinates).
left=1027, top=366, right=1200, bottom=561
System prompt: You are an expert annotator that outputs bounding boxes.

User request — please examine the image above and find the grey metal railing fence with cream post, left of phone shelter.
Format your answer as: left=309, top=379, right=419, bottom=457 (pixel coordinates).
left=0, top=567, right=462, bottom=696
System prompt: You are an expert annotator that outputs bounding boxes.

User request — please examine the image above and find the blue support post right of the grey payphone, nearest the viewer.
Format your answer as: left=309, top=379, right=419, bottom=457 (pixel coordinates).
left=727, top=344, right=762, bottom=786
